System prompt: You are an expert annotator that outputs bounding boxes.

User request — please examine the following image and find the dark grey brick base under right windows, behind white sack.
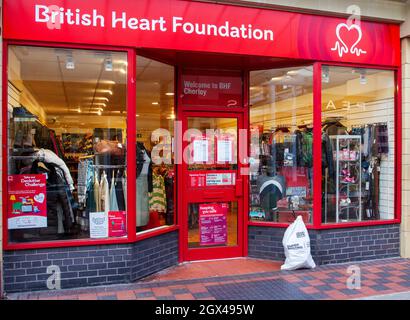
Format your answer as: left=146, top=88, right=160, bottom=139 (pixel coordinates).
left=248, top=225, right=400, bottom=265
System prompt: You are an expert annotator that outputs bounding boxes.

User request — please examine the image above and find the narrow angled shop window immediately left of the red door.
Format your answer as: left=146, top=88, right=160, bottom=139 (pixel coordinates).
left=136, top=56, right=175, bottom=233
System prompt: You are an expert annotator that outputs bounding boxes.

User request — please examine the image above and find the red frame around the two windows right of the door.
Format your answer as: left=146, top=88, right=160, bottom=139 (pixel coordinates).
left=247, top=62, right=402, bottom=230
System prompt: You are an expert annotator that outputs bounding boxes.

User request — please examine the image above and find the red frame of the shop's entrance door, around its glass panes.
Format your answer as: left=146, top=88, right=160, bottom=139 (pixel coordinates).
left=177, top=108, right=243, bottom=261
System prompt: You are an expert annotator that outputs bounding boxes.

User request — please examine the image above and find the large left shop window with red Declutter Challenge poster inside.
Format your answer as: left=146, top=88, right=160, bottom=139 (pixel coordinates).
left=6, top=46, right=127, bottom=242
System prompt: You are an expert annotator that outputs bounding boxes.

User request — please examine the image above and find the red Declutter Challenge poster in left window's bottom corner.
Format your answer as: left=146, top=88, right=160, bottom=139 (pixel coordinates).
left=7, top=174, right=47, bottom=230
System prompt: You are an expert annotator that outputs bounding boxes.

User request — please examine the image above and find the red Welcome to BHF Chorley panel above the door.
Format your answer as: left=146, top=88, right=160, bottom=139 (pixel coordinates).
left=179, top=74, right=242, bottom=107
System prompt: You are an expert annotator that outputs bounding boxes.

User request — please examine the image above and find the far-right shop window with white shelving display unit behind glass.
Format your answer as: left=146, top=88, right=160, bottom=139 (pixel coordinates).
left=322, top=66, right=395, bottom=223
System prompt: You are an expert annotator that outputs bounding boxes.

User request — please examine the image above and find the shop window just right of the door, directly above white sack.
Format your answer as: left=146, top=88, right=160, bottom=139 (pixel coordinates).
left=249, top=66, right=313, bottom=223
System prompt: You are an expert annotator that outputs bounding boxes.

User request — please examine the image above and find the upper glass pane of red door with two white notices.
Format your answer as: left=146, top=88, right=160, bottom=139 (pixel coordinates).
left=184, top=117, right=238, bottom=170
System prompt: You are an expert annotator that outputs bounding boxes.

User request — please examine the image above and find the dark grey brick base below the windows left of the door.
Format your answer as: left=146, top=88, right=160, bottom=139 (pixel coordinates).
left=3, top=231, right=178, bottom=292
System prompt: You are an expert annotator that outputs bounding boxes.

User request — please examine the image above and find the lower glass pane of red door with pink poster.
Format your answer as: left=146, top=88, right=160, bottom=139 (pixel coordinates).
left=188, top=202, right=238, bottom=248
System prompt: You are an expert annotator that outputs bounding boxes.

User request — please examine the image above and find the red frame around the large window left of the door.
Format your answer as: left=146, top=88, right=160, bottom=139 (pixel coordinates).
left=2, top=40, right=178, bottom=250
